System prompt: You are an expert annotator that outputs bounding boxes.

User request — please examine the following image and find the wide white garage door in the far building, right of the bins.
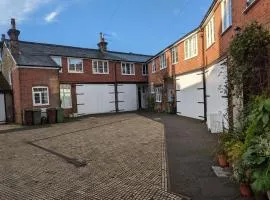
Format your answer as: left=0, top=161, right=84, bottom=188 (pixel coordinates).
left=76, top=84, right=115, bottom=115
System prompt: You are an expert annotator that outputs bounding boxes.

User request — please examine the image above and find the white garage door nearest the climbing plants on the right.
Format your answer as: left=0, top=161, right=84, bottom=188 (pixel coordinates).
left=206, top=63, right=228, bottom=133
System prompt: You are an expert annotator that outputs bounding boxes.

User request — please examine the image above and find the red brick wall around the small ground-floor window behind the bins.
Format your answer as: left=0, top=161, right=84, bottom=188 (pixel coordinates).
left=12, top=68, right=60, bottom=123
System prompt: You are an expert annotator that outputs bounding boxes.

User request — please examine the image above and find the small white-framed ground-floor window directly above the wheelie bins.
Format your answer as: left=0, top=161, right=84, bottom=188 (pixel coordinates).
left=32, top=87, right=49, bottom=106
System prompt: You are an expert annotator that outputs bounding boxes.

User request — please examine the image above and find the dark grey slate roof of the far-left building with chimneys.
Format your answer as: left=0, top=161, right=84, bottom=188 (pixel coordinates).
left=6, top=40, right=152, bottom=68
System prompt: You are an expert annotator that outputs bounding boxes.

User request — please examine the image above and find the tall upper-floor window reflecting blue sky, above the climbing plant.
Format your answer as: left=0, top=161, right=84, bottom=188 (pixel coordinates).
left=221, top=0, right=232, bottom=32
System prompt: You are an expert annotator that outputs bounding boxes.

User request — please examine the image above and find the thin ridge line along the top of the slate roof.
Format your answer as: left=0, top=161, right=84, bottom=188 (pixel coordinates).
left=19, top=40, right=152, bottom=57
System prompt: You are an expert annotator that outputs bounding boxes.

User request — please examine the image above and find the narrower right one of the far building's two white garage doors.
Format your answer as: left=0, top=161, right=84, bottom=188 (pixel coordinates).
left=118, top=84, right=138, bottom=112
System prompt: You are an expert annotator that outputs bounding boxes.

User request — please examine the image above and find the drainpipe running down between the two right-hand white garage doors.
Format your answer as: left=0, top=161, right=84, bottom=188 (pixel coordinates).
left=201, top=29, right=207, bottom=122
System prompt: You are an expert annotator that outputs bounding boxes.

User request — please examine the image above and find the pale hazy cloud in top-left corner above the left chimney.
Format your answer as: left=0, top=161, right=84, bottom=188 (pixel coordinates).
left=0, top=0, right=52, bottom=25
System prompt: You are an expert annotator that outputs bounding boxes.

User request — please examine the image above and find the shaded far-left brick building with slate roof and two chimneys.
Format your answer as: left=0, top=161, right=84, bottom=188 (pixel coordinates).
left=1, top=19, right=150, bottom=123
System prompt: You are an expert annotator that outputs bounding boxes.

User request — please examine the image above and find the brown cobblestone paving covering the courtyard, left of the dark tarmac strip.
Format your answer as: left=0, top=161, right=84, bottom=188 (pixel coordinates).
left=0, top=114, right=184, bottom=200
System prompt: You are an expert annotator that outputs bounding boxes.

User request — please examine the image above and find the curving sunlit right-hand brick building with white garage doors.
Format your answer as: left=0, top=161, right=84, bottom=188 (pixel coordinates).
left=148, top=0, right=270, bottom=132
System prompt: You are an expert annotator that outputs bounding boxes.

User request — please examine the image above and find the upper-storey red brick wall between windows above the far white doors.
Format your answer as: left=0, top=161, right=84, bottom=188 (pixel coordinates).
left=59, top=57, right=147, bottom=83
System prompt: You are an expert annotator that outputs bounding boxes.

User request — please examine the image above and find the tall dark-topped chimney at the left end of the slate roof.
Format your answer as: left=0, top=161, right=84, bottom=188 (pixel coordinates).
left=8, top=18, right=20, bottom=55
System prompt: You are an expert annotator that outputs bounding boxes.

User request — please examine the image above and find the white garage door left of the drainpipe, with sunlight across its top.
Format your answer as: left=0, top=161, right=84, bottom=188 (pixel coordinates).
left=176, top=71, right=204, bottom=120
